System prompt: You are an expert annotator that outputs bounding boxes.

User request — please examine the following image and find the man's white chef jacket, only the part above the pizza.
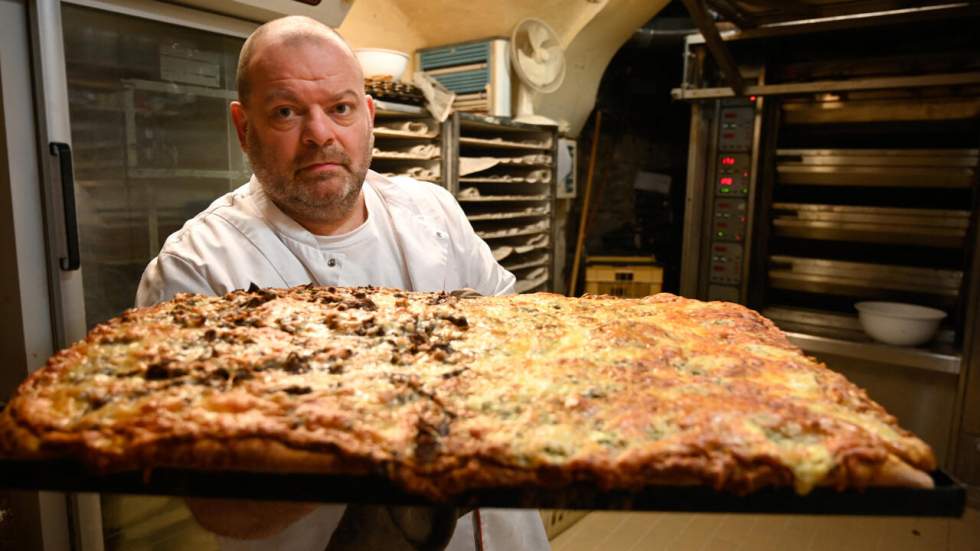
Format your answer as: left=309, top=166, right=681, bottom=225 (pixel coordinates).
left=136, top=171, right=514, bottom=306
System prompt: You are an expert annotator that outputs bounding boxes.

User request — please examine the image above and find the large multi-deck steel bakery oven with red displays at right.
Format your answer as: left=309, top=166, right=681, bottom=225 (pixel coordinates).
left=675, top=9, right=980, bottom=504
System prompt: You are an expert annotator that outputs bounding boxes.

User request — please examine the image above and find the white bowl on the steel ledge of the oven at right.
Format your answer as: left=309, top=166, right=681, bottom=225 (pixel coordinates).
left=854, top=302, right=946, bottom=346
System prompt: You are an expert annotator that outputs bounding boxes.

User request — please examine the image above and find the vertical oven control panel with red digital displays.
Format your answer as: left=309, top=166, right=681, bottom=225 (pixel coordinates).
left=701, top=98, right=756, bottom=302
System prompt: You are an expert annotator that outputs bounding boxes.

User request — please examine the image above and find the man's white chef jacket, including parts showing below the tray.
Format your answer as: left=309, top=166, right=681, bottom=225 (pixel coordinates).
left=136, top=171, right=549, bottom=551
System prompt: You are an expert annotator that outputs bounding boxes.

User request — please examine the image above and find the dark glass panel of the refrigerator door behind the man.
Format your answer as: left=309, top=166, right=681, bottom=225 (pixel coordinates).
left=62, top=4, right=249, bottom=550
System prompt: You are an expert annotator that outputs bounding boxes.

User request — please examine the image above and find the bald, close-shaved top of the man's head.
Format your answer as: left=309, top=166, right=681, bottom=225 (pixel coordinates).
left=235, top=15, right=363, bottom=105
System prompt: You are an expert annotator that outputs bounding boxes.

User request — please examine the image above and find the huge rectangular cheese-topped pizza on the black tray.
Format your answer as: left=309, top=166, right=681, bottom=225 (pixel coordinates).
left=0, top=286, right=935, bottom=501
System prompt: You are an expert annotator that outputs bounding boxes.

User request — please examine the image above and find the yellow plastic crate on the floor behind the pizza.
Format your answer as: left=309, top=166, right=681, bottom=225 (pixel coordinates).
left=585, top=256, right=664, bottom=298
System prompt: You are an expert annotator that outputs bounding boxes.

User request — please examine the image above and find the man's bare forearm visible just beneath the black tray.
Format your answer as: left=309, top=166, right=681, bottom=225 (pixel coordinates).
left=185, top=498, right=317, bottom=540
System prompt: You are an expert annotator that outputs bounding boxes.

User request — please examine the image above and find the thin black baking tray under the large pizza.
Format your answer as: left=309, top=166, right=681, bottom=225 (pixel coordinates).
left=0, top=459, right=966, bottom=517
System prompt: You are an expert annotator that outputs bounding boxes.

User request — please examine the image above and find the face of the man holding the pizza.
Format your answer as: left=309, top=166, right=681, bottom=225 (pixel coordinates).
left=232, top=38, right=374, bottom=225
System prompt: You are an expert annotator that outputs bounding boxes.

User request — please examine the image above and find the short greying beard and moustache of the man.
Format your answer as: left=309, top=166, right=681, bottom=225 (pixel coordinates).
left=245, top=129, right=374, bottom=223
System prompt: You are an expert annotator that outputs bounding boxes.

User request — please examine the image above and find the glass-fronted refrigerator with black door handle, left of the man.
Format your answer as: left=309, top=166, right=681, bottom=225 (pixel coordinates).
left=0, top=0, right=255, bottom=551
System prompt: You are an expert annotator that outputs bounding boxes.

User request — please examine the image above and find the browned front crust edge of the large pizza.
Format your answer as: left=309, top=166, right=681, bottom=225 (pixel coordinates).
left=0, top=404, right=934, bottom=502
